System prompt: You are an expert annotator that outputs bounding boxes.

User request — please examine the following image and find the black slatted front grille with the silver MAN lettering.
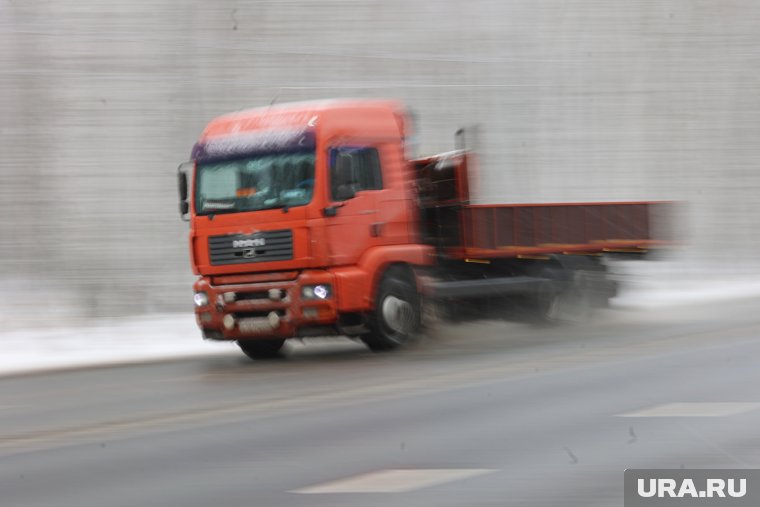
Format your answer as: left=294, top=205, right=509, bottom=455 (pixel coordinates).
left=208, top=230, right=293, bottom=266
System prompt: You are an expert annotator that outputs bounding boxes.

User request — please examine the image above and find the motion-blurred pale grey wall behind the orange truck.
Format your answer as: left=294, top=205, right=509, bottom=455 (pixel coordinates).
left=0, top=0, right=760, bottom=326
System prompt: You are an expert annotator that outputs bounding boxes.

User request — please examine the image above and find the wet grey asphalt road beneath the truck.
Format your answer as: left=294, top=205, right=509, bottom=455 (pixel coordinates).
left=0, top=300, right=760, bottom=507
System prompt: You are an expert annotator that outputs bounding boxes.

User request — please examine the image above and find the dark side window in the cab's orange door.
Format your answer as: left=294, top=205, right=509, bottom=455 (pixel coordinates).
left=330, top=146, right=383, bottom=201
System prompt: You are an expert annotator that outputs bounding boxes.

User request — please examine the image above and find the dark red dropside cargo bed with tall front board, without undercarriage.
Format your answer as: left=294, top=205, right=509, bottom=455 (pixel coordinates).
left=413, top=150, right=673, bottom=260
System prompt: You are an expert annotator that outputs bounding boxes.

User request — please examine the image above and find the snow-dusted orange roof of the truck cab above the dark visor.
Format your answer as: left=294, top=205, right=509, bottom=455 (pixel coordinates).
left=200, top=99, right=405, bottom=142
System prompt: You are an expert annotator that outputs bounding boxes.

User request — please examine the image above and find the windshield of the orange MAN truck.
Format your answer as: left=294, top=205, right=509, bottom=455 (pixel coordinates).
left=195, top=152, right=314, bottom=215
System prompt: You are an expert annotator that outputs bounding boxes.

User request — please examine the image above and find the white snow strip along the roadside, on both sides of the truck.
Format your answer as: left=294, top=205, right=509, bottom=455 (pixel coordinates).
left=0, top=270, right=760, bottom=375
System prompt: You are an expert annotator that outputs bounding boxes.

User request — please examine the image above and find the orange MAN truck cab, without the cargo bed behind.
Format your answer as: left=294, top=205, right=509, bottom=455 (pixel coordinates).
left=180, top=100, right=431, bottom=357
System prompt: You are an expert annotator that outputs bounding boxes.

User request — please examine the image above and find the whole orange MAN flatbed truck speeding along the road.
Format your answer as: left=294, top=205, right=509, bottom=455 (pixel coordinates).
left=178, top=100, right=666, bottom=359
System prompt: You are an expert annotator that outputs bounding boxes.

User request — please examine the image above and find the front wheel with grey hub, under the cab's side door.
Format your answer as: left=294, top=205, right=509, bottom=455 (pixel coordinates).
left=361, top=268, right=421, bottom=352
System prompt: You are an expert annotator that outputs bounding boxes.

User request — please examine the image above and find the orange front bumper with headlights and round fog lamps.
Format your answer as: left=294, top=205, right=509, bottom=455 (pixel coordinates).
left=193, top=270, right=338, bottom=340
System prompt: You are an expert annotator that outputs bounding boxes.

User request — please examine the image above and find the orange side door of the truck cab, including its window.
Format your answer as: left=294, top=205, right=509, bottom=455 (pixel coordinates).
left=327, top=146, right=383, bottom=265
